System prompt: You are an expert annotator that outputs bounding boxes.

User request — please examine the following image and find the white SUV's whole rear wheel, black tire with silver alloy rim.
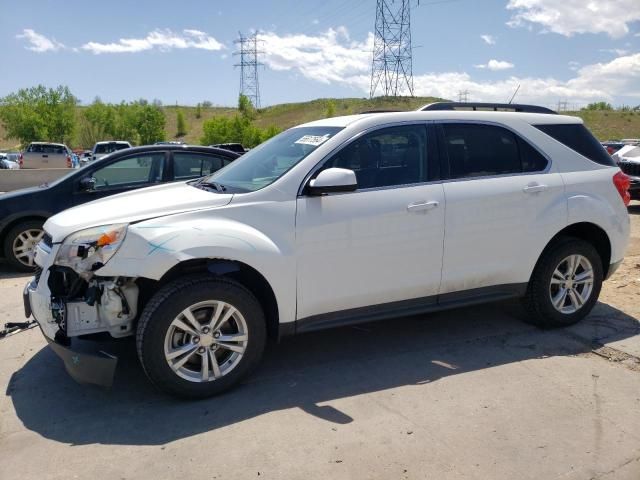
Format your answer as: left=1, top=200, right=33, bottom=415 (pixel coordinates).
left=524, top=238, right=604, bottom=328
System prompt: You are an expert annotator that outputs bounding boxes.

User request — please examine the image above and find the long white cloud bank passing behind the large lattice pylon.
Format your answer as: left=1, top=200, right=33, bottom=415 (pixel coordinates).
left=260, top=28, right=640, bottom=104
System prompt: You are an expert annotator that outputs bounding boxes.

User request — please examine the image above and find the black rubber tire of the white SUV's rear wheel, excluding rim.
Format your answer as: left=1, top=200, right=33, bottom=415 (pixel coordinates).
left=523, top=237, right=604, bottom=328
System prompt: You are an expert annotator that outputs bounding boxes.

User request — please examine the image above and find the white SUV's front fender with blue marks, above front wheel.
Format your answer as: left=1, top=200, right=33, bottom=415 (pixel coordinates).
left=96, top=207, right=296, bottom=323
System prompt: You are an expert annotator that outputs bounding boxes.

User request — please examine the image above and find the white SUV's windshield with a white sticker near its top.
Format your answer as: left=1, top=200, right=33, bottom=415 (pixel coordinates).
left=202, top=127, right=342, bottom=193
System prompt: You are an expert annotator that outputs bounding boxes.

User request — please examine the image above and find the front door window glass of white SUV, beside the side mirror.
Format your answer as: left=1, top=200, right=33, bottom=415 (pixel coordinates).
left=318, top=125, right=427, bottom=190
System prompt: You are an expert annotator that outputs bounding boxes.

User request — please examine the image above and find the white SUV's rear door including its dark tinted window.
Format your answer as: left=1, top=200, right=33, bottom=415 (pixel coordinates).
left=438, top=122, right=567, bottom=299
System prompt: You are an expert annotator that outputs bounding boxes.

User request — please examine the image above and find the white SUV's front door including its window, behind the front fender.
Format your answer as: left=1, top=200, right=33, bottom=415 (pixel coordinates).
left=296, top=124, right=445, bottom=319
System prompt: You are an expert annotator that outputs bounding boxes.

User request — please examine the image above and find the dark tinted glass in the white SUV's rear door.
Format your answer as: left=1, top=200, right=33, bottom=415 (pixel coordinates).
left=442, top=123, right=522, bottom=178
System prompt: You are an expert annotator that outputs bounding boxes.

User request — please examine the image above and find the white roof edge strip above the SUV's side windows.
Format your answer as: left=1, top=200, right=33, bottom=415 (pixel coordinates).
left=299, top=110, right=583, bottom=127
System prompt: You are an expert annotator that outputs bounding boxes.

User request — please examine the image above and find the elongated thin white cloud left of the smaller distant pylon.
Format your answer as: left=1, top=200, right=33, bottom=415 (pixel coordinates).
left=81, top=29, right=225, bottom=55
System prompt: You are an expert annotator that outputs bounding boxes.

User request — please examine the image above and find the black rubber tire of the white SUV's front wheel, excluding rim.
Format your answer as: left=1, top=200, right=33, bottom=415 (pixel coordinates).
left=136, top=276, right=267, bottom=399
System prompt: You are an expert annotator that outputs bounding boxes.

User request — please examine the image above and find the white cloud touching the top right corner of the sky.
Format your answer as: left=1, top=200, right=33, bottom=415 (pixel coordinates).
left=507, top=0, right=640, bottom=38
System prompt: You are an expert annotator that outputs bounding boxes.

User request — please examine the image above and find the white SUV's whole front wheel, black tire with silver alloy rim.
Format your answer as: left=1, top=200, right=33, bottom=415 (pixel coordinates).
left=136, top=276, right=267, bottom=398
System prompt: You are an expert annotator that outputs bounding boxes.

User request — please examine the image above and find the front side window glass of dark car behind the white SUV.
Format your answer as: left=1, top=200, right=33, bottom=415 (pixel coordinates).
left=93, top=152, right=165, bottom=190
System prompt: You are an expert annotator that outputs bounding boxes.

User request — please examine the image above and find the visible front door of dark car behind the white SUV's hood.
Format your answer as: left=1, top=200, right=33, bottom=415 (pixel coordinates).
left=74, top=151, right=168, bottom=205
